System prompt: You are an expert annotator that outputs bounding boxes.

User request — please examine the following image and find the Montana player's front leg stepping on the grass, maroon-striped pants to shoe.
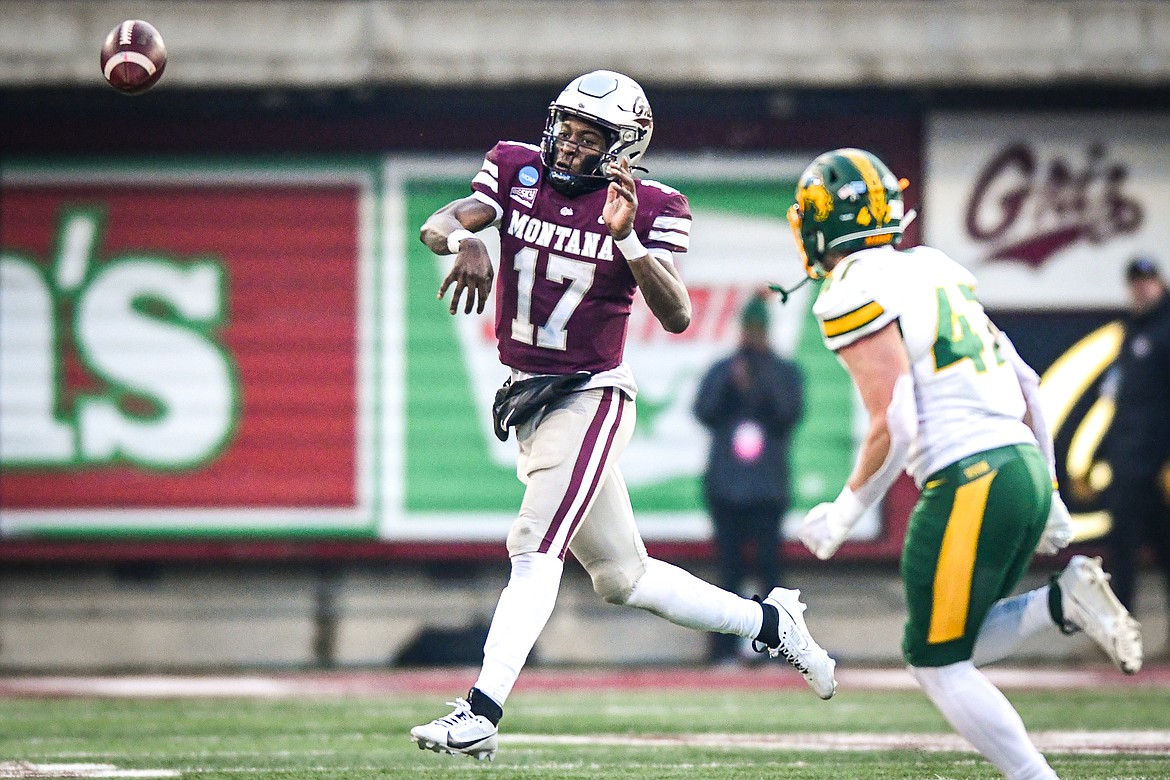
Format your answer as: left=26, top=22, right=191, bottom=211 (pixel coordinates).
left=411, top=388, right=633, bottom=758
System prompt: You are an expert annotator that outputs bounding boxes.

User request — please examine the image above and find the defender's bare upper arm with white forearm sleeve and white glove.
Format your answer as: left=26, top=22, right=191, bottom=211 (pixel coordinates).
left=800, top=322, right=918, bottom=559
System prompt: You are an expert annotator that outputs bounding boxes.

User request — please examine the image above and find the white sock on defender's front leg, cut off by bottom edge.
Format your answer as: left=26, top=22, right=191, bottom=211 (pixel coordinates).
left=910, top=661, right=1057, bottom=780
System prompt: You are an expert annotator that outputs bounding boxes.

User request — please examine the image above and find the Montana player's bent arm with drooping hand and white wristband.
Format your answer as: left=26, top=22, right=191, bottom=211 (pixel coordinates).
left=419, top=196, right=497, bottom=315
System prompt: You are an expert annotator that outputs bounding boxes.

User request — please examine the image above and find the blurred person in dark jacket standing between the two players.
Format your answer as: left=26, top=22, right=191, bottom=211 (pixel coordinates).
left=694, top=294, right=804, bottom=662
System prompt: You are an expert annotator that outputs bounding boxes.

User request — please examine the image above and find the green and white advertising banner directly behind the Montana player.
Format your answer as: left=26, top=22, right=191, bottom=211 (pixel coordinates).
left=381, top=158, right=878, bottom=540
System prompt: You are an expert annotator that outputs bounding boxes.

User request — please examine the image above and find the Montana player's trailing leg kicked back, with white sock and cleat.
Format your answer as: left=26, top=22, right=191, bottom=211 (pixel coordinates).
left=570, top=467, right=837, bottom=699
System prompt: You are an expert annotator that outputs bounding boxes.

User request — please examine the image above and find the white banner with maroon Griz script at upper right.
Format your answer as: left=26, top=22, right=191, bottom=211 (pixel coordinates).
left=922, top=113, right=1170, bottom=310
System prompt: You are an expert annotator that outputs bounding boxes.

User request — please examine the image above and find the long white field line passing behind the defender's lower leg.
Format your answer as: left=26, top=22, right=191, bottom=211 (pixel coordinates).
left=500, top=731, right=1170, bottom=755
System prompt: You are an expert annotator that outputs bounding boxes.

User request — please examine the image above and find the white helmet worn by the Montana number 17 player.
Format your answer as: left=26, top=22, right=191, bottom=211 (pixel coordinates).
left=541, top=70, right=654, bottom=195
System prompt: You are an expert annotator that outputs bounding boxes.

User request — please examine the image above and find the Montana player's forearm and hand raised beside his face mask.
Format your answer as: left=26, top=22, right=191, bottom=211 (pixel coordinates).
left=601, top=158, right=690, bottom=333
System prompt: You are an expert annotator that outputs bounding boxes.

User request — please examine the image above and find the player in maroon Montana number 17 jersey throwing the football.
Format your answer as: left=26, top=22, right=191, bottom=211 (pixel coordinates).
left=411, top=70, right=835, bottom=759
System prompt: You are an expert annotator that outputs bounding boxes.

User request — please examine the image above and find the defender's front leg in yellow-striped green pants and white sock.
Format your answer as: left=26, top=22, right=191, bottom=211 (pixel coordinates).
left=902, top=447, right=1057, bottom=780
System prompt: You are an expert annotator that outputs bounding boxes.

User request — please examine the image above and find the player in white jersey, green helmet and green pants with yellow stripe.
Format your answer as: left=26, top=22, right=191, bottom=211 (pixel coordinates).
left=789, top=149, right=1142, bottom=780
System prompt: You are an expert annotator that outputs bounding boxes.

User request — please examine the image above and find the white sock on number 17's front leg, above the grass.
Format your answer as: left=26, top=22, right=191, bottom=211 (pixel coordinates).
left=475, top=552, right=564, bottom=706
